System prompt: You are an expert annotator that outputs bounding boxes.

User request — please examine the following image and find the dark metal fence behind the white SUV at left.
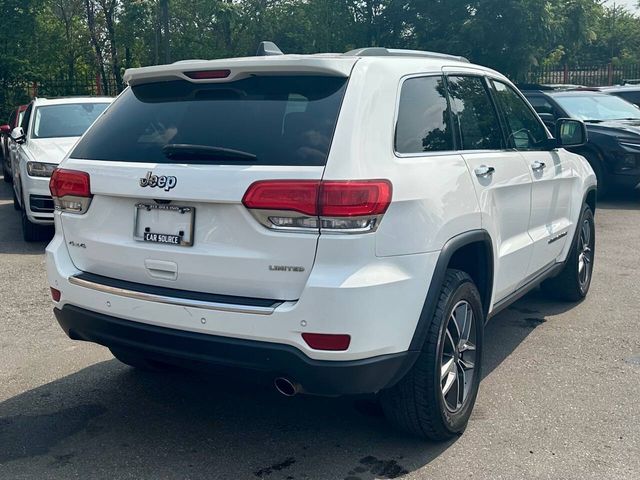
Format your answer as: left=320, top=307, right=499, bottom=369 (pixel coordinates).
left=0, top=75, right=123, bottom=123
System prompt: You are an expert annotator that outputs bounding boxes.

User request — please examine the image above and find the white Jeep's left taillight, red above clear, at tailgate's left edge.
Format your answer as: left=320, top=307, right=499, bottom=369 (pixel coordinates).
left=49, top=168, right=93, bottom=214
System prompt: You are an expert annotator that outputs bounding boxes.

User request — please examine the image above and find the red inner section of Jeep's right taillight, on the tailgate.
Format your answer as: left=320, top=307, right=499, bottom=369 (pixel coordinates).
left=242, top=180, right=320, bottom=216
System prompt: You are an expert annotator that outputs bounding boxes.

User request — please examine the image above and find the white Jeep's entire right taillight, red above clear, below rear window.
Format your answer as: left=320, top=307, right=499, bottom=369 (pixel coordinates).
left=242, top=180, right=392, bottom=233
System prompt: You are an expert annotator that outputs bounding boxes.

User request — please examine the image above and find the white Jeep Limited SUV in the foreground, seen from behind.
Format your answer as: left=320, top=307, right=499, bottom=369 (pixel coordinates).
left=47, top=48, right=596, bottom=440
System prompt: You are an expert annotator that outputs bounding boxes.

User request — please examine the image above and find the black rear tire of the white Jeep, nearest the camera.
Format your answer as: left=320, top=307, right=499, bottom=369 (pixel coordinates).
left=380, top=270, right=484, bottom=441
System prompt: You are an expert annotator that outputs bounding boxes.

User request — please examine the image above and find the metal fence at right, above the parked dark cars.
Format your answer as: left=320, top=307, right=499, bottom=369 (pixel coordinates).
left=527, top=64, right=640, bottom=87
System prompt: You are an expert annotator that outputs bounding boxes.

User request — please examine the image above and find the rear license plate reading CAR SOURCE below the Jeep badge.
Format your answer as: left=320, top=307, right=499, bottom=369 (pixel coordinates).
left=133, top=203, right=195, bottom=247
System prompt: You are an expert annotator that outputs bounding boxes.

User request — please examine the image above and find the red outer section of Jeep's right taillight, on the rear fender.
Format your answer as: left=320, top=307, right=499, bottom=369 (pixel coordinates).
left=319, top=180, right=392, bottom=217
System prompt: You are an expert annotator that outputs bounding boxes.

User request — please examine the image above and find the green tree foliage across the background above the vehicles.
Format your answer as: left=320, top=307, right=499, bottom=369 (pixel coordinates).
left=0, top=0, right=640, bottom=106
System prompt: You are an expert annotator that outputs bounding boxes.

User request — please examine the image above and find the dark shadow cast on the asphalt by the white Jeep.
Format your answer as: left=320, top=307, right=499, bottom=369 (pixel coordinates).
left=0, top=292, right=560, bottom=480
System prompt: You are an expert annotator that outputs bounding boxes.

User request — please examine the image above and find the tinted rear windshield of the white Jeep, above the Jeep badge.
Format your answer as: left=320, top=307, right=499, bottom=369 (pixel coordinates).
left=71, top=76, right=347, bottom=165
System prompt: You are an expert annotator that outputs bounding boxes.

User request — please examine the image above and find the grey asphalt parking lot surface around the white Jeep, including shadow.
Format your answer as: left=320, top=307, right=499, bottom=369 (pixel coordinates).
left=0, top=174, right=640, bottom=480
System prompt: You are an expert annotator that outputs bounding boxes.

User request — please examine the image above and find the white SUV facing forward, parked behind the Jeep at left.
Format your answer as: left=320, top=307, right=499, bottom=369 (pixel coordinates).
left=11, top=97, right=113, bottom=242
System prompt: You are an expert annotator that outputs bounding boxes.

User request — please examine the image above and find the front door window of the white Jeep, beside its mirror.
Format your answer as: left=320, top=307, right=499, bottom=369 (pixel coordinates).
left=493, top=81, right=547, bottom=150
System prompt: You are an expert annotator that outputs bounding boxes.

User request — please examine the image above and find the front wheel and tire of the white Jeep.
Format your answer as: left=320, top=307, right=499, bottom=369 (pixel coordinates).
left=542, top=204, right=596, bottom=302
